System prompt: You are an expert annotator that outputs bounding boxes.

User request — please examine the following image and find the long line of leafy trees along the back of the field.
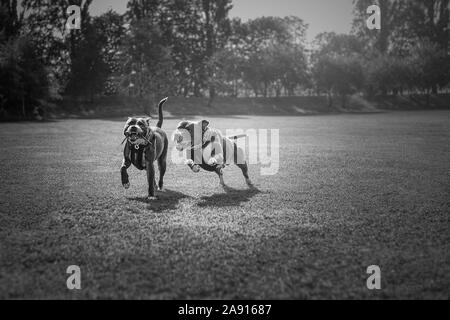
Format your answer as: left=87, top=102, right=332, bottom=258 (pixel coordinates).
left=0, top=0, right=450, bottom=118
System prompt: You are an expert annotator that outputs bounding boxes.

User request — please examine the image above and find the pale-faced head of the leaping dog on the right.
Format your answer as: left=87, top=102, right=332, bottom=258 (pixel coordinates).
left=173, top=120, right=209, bottom=151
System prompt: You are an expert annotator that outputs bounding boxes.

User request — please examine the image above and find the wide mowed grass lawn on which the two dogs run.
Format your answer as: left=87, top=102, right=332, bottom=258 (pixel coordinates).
left=0, top=111, right=450, bottom=299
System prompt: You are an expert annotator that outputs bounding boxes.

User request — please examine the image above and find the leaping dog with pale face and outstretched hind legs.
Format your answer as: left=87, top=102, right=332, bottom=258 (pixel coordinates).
left=173, top=120, right=253, bottom=187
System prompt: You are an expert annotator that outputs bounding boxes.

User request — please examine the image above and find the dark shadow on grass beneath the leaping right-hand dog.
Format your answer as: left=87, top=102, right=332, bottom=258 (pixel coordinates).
left=198, top=186, right=262, bottom=208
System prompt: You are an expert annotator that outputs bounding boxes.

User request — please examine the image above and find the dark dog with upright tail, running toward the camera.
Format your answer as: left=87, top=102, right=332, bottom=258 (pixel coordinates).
left=120, top=98, right=169, bottom=199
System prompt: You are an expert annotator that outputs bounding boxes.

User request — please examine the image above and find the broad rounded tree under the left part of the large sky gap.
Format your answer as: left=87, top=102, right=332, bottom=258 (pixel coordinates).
left=230, top=16, right=308, bottom=97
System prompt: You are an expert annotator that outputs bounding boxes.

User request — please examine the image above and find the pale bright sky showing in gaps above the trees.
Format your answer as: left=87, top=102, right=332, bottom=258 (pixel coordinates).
left=91, top=0, right=353, bottom=40
